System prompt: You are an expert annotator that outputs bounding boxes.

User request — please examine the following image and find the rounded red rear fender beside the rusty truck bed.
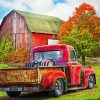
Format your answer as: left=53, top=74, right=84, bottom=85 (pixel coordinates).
left=41, top=71, right=66, bottom=89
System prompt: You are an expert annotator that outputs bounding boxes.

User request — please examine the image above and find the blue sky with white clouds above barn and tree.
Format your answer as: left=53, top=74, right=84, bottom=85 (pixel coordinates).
left=0, top=0, right=100, bottom=23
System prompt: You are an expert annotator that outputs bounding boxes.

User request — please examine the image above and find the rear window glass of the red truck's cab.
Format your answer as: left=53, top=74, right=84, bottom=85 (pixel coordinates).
left=33, top=51, right=61, bottom=61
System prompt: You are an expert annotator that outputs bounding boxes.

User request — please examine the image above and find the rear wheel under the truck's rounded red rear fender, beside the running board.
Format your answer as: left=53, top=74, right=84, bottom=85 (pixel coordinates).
left=49, top=79, right=64, bottom=97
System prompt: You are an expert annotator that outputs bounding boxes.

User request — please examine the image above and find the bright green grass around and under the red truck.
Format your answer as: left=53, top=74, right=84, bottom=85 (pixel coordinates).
left=0, top=59, right=100, bottom=100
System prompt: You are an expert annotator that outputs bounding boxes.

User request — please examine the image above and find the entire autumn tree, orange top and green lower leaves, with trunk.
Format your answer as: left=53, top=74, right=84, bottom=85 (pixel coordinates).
left=58, top=3, right=100, bottom=64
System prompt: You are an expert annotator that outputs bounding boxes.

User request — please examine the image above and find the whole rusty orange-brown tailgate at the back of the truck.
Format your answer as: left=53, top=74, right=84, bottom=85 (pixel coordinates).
left=0, top=68, right=38, bottom=85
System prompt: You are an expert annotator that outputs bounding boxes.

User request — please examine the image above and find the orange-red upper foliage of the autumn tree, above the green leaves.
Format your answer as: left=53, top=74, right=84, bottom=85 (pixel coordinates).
left=58, top=3, right=100, bottom=39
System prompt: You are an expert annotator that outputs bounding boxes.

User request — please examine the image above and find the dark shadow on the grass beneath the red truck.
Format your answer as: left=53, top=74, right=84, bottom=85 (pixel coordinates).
left=0, top=91, right=79, bottom=100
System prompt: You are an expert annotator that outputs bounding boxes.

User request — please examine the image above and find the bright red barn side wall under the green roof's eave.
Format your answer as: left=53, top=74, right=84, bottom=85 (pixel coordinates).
left=32, top=33, right=57, bottom=47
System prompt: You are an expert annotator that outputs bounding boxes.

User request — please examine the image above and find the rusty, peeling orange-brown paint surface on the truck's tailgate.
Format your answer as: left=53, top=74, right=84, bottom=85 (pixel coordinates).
left=0, top=69, right=37, bottom=84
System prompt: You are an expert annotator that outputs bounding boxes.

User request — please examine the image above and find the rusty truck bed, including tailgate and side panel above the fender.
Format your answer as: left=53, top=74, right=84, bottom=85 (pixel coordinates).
left=0, top=66, right=64, bottom=85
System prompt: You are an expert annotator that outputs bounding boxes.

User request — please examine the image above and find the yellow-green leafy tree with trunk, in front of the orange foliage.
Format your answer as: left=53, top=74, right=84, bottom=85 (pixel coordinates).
left=62, top=28, right=97, bottom=65
